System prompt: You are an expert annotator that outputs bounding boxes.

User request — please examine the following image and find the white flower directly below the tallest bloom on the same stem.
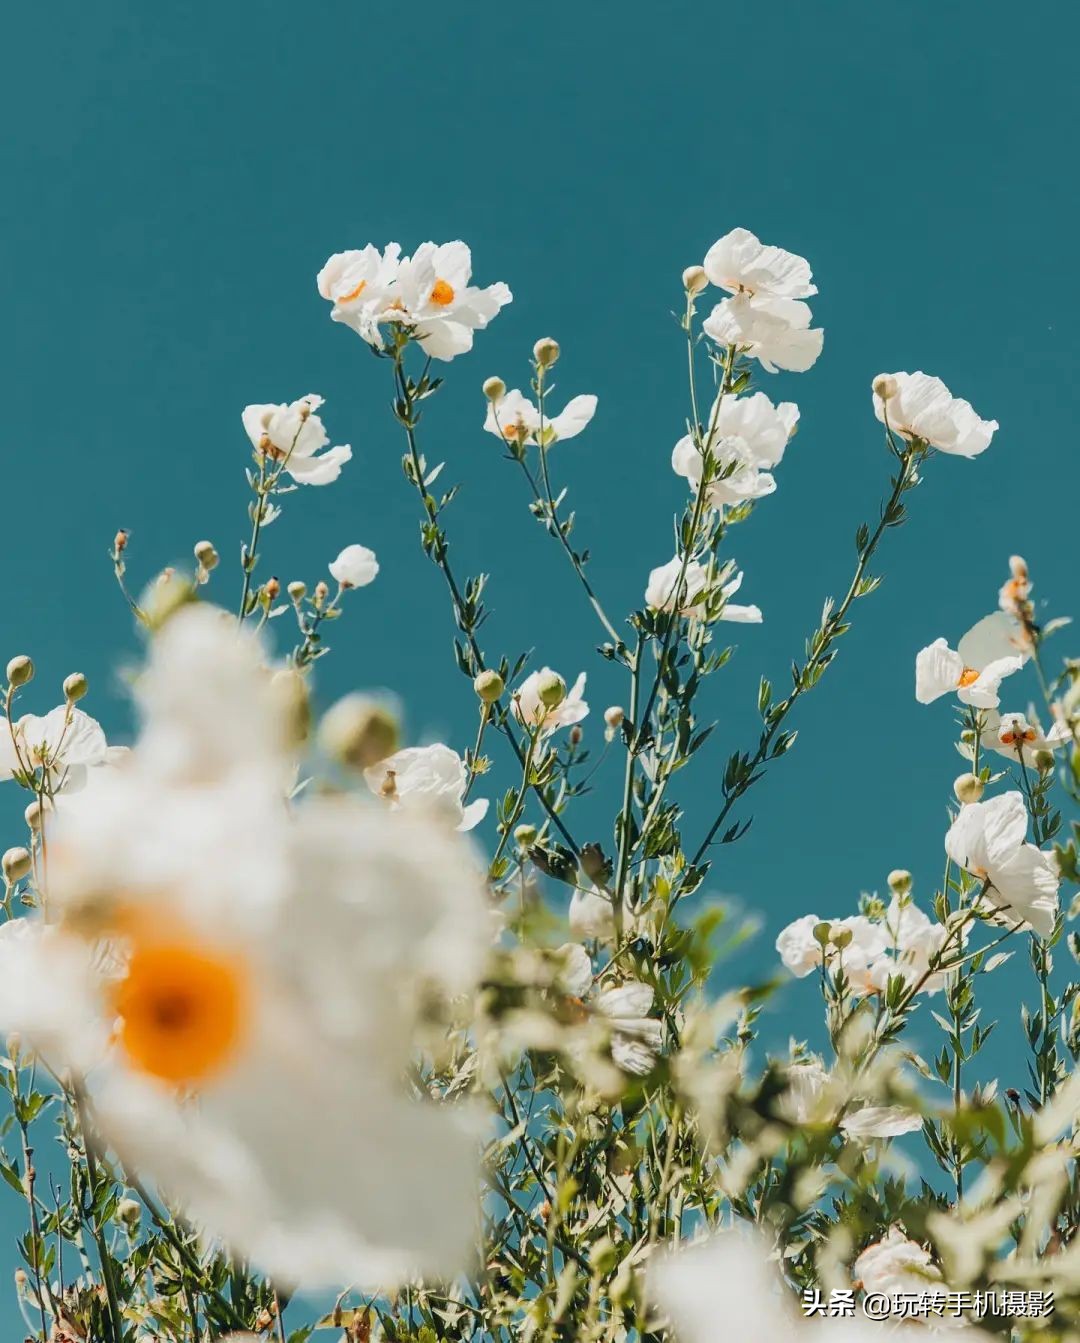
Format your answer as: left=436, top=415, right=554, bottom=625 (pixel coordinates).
left=672, top=392, right=799, bottom=509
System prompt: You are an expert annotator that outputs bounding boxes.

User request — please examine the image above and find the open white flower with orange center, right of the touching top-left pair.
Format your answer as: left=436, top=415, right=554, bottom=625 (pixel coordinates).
left=394, top=242, right=513, bottom=360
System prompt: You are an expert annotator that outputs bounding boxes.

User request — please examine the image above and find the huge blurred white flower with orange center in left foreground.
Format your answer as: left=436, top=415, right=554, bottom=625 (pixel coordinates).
left=0, top=611, right=489, bottom=1291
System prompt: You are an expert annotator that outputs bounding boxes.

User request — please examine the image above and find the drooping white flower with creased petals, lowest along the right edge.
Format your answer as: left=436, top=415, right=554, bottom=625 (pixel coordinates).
left=946, top=792, right=1060, bottom=937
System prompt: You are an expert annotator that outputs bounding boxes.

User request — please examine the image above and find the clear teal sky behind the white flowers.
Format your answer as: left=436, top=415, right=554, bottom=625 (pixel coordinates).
left=0, top=0, right=1080, bottom=1309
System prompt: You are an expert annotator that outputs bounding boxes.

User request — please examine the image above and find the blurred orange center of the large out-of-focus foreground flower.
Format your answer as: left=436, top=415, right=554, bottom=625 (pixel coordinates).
left=113, top=935, right=250, bottom=1086
